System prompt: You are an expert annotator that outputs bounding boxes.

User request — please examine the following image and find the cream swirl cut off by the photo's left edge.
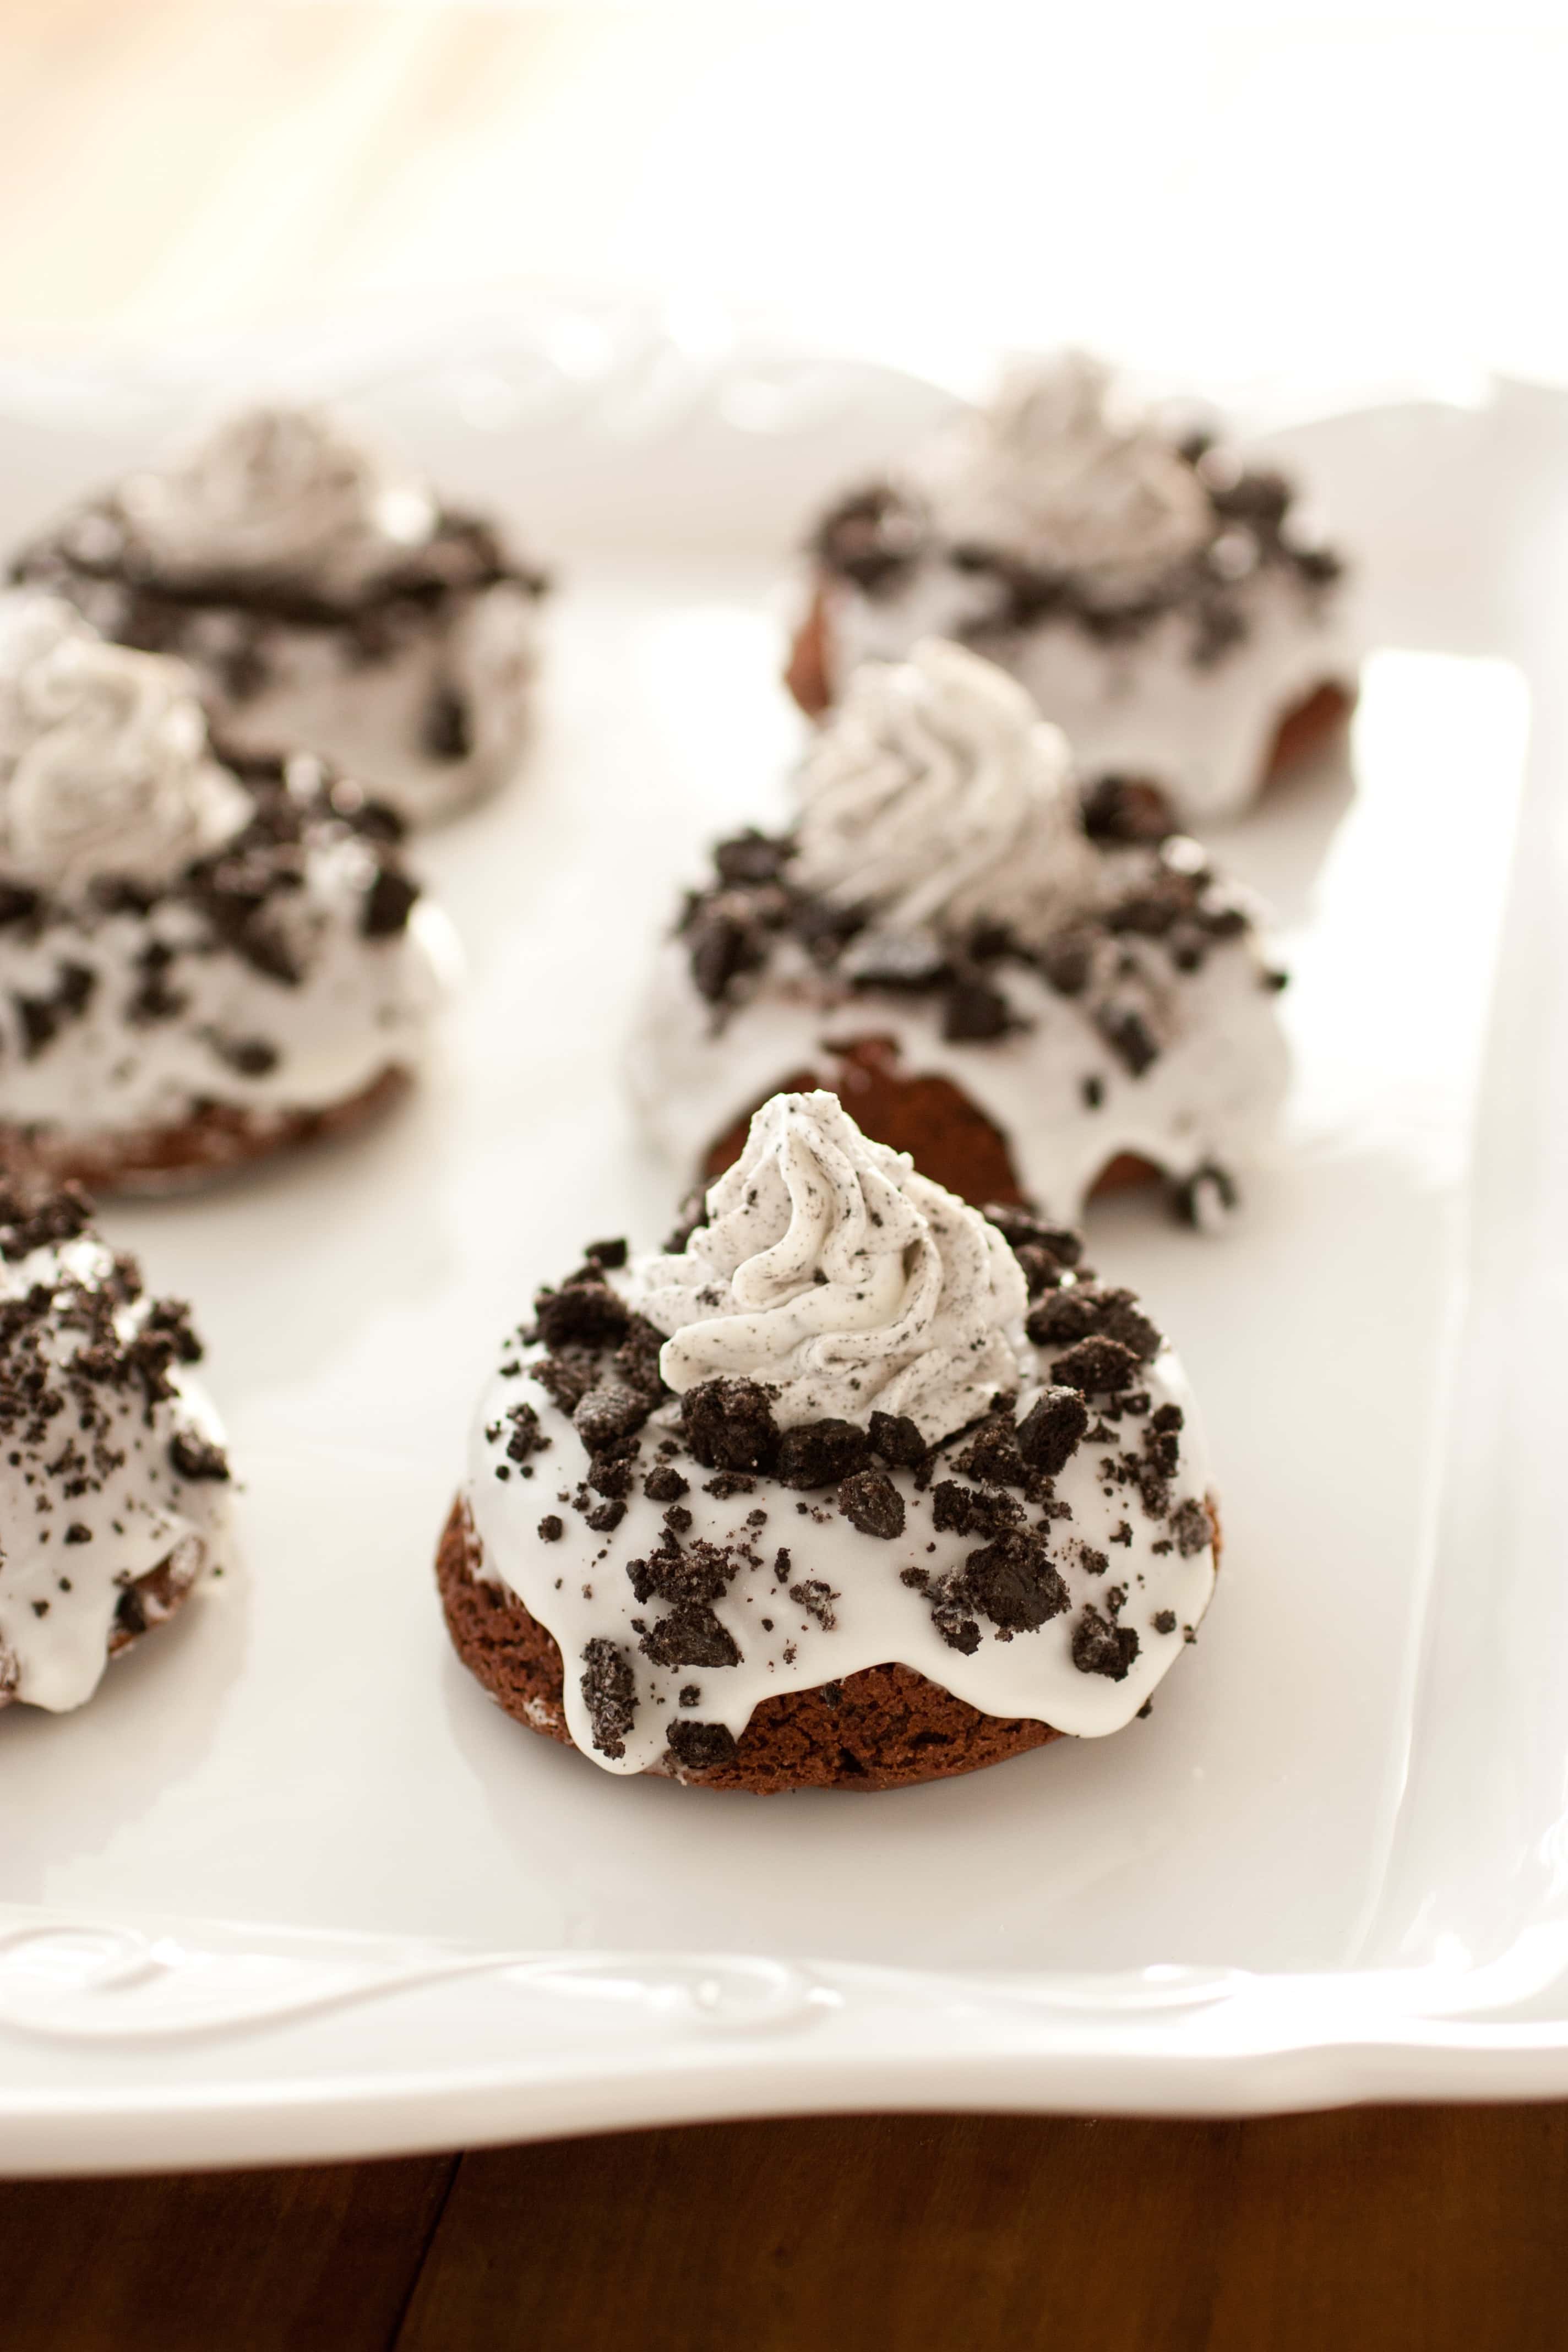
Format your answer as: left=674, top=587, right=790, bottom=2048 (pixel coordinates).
left=0, top=595, right=249, bottom=894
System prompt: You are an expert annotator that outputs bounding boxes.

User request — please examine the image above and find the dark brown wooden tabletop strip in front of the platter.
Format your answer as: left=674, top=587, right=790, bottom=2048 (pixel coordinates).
left=0, top=2108, right=1568, bottom=2352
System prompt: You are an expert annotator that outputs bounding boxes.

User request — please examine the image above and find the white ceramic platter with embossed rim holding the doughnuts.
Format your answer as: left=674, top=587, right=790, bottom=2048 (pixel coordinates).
left=0, top=336, right=1568, bottom=2173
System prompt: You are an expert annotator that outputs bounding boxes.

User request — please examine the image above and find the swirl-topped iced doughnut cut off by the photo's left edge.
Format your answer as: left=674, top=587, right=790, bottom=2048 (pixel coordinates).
left=0, top=590, right=456, bottom=1193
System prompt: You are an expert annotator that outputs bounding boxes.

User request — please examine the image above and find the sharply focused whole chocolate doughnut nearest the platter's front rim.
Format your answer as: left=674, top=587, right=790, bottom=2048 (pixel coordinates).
left=437, top=1091, right=1220, bottom=1795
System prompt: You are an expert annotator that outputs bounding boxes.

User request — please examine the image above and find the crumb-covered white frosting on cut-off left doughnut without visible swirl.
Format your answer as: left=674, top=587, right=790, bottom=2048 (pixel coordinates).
left=0, top=1193, right=228, bottom=1712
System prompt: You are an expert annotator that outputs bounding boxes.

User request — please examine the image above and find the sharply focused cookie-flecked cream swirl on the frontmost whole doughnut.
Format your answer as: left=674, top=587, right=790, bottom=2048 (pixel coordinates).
left=630, top=1093, right=1030, bottom=1442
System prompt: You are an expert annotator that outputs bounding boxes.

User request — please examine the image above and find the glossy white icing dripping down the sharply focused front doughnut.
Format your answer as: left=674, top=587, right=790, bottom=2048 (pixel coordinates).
left=465, top=1298, right=1216, bottom=1773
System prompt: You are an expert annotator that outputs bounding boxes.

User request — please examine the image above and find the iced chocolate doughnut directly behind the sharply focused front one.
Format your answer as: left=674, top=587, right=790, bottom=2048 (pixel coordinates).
left=628, top=640, right=1288, bottom=1228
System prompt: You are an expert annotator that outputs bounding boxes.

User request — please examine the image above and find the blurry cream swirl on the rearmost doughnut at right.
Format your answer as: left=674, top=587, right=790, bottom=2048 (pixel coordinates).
left=926, top=353, right=1213, bottom=602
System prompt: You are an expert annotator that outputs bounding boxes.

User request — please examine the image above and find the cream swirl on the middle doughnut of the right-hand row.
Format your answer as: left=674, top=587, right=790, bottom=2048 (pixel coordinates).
left=792, top=638, right=1098, bottom=936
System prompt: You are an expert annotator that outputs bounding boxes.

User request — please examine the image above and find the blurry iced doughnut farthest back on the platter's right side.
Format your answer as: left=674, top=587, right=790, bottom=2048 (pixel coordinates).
left=785, top=353, right=1354, bottom=825
